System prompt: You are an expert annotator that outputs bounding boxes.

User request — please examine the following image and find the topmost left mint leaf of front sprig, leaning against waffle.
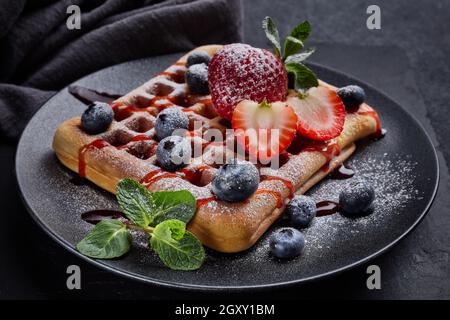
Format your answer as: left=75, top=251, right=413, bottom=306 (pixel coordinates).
left=116, top=179, right=153, bottom=227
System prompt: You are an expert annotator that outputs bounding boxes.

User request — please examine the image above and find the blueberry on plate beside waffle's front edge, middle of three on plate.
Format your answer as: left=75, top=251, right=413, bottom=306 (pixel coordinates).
left=286, top=196, right=316, bottom=228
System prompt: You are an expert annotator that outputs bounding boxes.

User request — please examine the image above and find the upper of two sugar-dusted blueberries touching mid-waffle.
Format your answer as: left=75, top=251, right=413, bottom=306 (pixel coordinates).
left=155, top=108, right=189, bottom=140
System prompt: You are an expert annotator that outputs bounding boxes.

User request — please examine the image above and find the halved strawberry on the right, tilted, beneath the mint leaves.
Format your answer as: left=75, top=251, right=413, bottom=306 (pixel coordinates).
left=286, top=87, right=345, bottom=141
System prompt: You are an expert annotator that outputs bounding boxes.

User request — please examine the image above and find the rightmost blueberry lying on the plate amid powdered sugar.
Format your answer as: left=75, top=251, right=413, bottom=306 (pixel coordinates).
left=339, top=181, right=375, bottom=215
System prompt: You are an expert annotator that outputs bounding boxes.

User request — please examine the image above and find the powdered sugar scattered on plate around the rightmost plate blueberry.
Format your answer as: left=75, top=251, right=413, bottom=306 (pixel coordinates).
left=298, top=154, right=421, bottom=246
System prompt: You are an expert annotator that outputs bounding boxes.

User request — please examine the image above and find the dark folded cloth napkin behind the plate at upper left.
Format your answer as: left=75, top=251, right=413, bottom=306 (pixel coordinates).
left=0, top=0, right=242, bottom=140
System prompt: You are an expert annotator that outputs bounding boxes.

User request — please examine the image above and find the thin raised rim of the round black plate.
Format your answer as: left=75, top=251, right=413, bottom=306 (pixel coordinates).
left=14, top=56, right=440, bottom=292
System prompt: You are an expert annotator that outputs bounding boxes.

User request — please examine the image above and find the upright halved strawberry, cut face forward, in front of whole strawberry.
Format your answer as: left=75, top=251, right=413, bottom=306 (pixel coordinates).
left=231, top=100, right=297, bottom=162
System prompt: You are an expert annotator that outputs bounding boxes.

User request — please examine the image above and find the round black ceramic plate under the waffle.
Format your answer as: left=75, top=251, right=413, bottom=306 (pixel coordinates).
left=16, top=55, right=438, bottom=290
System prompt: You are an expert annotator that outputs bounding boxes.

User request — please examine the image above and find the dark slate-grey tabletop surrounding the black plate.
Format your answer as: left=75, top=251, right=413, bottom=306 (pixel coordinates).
left=0, top=0, right=450, bottom=299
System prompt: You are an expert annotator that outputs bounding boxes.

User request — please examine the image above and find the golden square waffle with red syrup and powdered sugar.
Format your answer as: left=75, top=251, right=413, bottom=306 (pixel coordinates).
left=53, top=45, right=379, bottom=252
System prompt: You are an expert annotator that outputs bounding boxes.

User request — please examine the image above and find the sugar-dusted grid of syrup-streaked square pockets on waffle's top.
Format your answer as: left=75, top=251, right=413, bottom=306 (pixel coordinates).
left=80, top=55, right=306, bottom=197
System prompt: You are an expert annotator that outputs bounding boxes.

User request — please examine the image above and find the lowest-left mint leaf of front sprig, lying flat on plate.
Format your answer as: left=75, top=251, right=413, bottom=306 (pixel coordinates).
left=77, top=219, right=131, bottom=259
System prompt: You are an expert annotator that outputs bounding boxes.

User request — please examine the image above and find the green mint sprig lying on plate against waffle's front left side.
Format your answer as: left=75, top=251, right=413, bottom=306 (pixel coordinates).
left=77, top=179, right=205, bottom=270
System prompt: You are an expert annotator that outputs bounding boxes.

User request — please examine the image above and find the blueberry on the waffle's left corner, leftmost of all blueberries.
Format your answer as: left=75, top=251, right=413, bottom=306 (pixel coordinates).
left=81, top=102, right=114, bottom=134
